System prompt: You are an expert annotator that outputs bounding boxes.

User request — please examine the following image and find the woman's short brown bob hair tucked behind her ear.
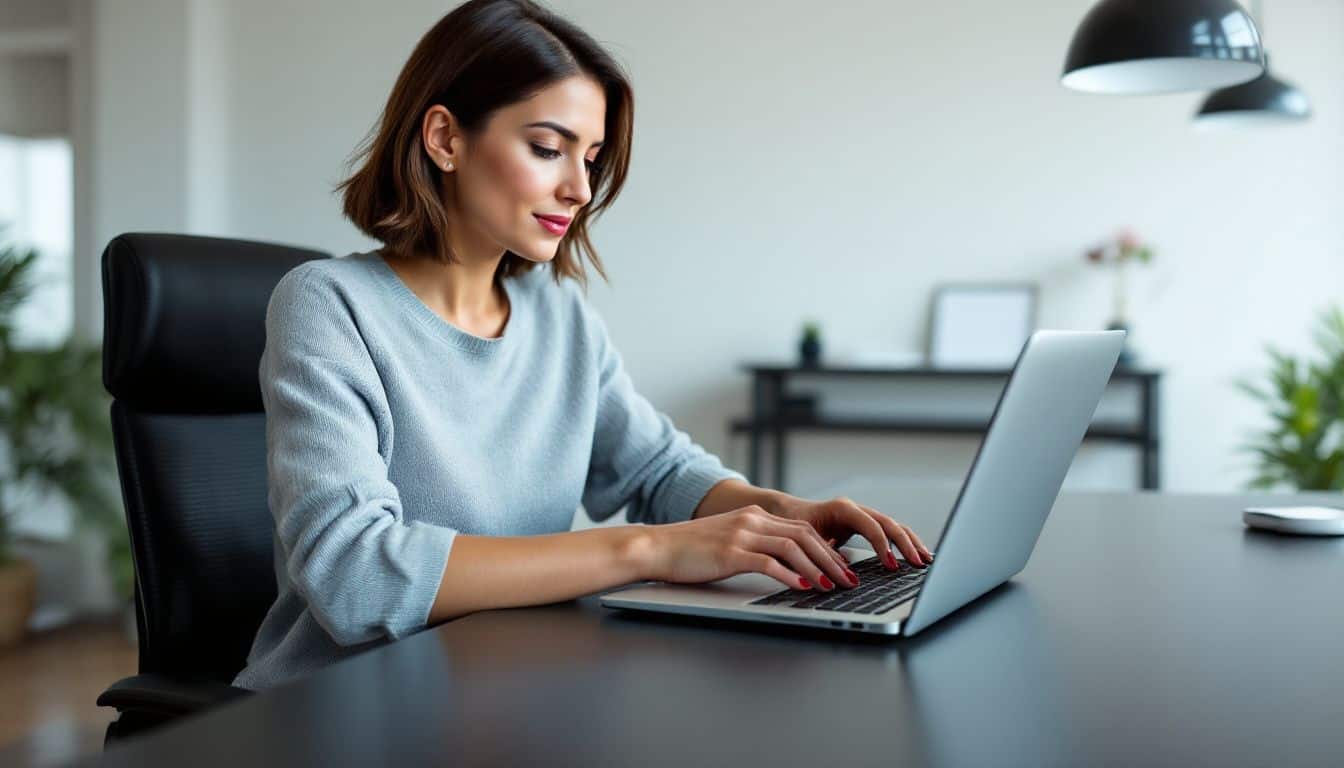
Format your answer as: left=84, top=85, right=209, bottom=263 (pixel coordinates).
left=336, top=0, right=634, bottom=285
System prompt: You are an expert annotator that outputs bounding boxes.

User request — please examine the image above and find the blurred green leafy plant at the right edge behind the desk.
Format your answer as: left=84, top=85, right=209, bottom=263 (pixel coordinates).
left=1236, top=307, right=1344, bottom=491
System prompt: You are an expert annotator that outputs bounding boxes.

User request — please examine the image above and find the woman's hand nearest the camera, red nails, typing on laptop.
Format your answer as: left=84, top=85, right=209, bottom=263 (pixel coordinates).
left=642, top=506, right=859, bottom=592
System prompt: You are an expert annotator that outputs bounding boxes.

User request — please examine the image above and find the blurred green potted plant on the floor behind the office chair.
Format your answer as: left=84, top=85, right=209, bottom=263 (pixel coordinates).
left=0, top=234, right=133, bottom=644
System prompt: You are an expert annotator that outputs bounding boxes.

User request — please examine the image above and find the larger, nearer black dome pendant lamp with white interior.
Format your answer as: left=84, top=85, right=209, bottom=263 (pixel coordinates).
left=1060, top=0, right=1265, bottom=94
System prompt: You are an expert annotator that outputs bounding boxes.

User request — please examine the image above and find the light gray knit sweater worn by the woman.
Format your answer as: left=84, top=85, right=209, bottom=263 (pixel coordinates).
left=234, top=252, right=742, bottom=689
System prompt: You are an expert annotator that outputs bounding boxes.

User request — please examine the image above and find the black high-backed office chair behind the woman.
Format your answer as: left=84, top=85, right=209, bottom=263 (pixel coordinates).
left=98, top=234, right=329, bottom=741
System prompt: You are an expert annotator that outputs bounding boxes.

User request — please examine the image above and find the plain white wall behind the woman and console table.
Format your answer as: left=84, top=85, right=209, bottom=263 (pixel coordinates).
left=86, top=0, right=1344, bottom=492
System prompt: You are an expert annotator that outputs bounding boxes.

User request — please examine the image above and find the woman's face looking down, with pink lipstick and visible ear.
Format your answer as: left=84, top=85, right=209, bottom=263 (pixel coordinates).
left=425, top=75, right=606, bottom=262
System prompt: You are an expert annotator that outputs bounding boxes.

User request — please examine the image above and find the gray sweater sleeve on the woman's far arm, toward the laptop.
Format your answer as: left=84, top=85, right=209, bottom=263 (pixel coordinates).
left=581, top=300, right=746, bottom=523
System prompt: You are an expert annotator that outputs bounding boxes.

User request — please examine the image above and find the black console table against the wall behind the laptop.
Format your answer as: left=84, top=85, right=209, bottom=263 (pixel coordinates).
left=728, top=363, right=1161, bottom=491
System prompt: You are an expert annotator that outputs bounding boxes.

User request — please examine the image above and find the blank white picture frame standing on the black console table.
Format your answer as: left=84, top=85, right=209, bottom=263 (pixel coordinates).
left=927, top=282, right=1038, bottom=370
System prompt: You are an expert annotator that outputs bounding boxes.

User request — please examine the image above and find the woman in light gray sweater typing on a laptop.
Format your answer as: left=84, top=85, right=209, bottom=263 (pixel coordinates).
left=235, top=0, right=931, bottom=689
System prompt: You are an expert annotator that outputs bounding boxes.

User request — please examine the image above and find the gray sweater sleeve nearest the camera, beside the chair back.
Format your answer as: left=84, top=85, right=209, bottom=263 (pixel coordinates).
left=259, top=266, right=456, bottom=646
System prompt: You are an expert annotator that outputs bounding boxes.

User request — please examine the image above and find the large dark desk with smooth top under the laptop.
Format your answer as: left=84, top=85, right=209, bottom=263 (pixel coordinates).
left=105, top=484, right=1344, bottom=768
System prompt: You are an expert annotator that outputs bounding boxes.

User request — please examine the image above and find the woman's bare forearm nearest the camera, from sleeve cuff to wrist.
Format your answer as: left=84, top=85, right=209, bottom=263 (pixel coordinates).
left=429, top=526, right=653, bottom=624
